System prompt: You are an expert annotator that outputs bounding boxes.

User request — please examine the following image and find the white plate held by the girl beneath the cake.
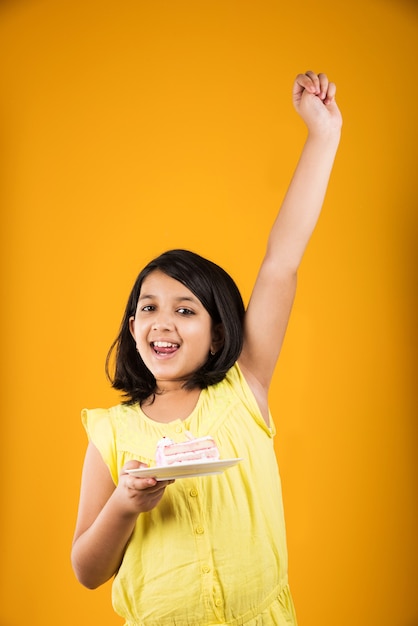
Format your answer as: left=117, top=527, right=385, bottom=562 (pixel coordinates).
left=126, top=459, right=242, bottom=480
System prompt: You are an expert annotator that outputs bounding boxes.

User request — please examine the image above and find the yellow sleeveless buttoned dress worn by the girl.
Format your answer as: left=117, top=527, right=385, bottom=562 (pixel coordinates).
left=82, top=365, right=296, bottom=626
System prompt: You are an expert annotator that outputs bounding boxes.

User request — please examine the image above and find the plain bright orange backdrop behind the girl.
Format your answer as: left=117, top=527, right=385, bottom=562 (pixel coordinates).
left=0, top=0, right=418, bottom=626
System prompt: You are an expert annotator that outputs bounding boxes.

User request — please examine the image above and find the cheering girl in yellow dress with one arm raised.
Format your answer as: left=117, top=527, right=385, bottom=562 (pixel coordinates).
left=72, top=72, right=341, bottom=626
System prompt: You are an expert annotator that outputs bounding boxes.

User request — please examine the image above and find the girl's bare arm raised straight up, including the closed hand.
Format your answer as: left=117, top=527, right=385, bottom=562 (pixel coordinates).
left=239, top=72, right=342, bottom=418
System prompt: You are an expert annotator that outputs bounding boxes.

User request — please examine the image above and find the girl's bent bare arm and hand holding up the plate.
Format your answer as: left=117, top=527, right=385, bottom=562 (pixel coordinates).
left=71, top=443, right=172, bottom=589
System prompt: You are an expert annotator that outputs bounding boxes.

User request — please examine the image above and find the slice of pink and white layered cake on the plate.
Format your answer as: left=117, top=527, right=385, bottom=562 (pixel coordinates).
left=155, top=432, right=219, bottom=467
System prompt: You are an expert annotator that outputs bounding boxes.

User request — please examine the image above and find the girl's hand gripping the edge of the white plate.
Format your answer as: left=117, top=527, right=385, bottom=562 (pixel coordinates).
left=115, top=461, right=174, bottom=514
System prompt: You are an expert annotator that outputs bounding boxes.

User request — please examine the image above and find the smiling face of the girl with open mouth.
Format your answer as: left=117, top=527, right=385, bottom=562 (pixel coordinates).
left=129, top=270, right=222, bottom=389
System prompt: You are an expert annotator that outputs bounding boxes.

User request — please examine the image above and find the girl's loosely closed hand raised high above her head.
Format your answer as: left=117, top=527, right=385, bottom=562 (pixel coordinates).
left=293, top=71, right=342, bottom=135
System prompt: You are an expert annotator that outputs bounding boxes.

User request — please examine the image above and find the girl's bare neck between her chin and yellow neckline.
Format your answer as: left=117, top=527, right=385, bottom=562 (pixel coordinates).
left=141, top=387, right=201, bottom=424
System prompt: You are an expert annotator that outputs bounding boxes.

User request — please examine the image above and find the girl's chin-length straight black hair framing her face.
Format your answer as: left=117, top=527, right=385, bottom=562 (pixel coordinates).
left=106, top=250, right=245, bottom=404
